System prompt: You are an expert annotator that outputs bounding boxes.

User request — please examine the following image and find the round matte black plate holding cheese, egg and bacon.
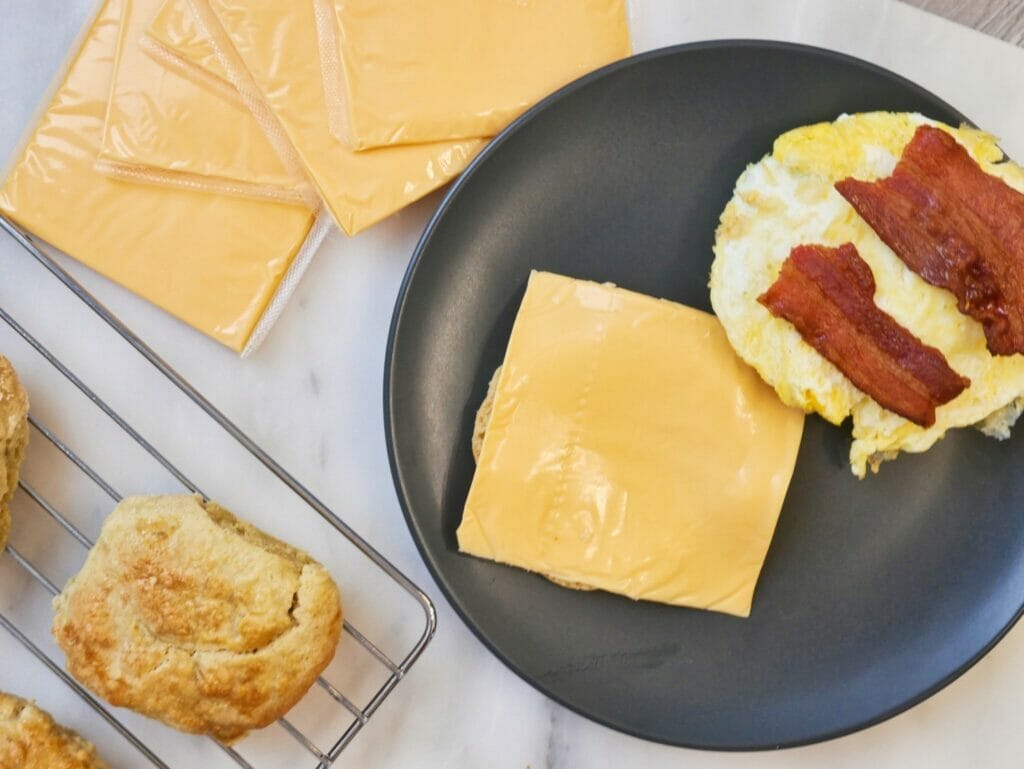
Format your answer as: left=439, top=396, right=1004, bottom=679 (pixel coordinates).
left=385, top=41, right=1024, bottom=750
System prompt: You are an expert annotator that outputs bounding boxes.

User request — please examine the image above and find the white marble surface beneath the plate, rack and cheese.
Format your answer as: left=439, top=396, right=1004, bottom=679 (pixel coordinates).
left=0, top=0, right=1024, bottom=769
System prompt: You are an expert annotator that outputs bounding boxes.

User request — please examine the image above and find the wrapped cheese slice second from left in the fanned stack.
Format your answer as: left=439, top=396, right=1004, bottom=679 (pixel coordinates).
left=97, top=0, right=314, bottom=203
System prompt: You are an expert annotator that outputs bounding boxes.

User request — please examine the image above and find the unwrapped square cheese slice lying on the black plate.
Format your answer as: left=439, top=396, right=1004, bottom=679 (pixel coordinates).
left=458, top=272, right=804, bottom=616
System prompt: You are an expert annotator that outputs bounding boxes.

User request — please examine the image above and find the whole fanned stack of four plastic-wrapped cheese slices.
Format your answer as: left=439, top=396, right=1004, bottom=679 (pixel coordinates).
left=0, top=0, right=629, bottom=350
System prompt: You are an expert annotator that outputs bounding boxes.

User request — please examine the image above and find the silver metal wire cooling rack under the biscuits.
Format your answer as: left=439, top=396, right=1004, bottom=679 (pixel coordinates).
left=0, top=216, right=436, bottom=769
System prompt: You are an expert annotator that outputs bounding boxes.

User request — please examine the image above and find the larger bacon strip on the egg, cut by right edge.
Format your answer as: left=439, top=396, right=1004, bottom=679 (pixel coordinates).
left=836, top=126, right=1024, bottom=355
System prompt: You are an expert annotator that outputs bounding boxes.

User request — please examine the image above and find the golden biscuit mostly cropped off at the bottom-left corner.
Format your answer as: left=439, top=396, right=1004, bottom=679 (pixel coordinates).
left=0, top=691, right=109, bottom=769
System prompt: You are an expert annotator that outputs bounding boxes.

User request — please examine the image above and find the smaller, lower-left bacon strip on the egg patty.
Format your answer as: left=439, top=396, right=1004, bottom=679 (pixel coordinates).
left=758, top=243, right=971, bottom=427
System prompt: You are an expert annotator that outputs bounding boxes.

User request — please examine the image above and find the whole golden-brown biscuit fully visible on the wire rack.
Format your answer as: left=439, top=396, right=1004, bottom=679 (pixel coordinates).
left=53, top=496, right=341, bottom=742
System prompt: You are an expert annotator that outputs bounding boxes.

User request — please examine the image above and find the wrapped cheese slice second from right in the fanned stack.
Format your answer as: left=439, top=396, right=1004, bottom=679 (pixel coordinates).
left=148, top=0, right=483, bottom=234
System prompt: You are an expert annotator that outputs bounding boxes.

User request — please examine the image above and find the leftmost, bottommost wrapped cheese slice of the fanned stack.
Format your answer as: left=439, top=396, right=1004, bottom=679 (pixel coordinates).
left=0, top=0, right=313, bottom=350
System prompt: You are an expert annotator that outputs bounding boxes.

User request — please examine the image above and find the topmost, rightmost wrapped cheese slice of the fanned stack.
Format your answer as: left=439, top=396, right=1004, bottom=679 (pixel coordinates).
left=309, top=0, right=631, bottom=149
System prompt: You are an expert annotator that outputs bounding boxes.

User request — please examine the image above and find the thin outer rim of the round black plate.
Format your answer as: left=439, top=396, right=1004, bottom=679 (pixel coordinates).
left=383, top=38, right=1007, bottom=753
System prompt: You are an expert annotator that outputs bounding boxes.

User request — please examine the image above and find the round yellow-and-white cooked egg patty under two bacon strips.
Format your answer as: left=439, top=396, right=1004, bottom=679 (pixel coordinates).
left=711, top=113, right=1024, bottom=477
